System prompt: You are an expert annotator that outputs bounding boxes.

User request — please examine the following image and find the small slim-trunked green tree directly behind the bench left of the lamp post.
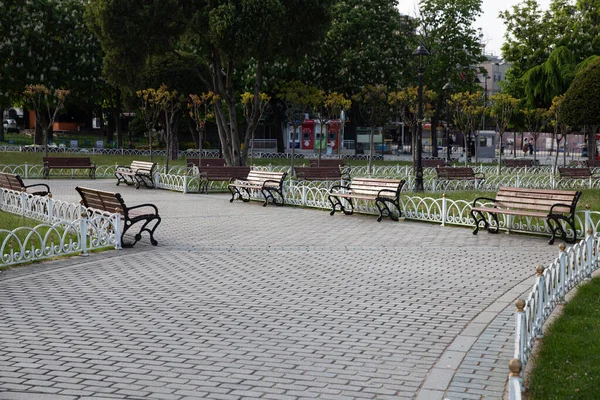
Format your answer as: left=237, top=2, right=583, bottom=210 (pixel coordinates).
left=353, top=85, right=390, bottom=175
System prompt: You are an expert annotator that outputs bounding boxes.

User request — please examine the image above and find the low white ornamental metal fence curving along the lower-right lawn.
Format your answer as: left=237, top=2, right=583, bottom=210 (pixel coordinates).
left=509, top=231, right=600, bottom=400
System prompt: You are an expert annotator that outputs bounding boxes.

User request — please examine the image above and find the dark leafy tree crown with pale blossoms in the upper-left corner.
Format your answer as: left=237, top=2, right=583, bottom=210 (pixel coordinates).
left=0, top=0, right=102, bottom=144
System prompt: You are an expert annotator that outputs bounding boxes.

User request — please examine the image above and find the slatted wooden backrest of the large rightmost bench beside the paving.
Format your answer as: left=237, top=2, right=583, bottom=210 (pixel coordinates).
left=494, top=187, right=581, bottom=214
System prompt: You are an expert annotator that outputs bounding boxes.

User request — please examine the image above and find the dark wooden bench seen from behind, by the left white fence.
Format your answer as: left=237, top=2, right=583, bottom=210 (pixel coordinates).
left=75, top=187, right=161, bottom=247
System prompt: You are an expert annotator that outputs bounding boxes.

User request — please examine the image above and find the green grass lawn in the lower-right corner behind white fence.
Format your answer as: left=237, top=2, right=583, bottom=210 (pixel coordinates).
left=527, top=278, right=600, bottom=400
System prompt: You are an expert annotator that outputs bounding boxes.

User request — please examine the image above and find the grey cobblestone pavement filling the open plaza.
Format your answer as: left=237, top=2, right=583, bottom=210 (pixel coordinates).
left=0, top=180, right=557, bottom=400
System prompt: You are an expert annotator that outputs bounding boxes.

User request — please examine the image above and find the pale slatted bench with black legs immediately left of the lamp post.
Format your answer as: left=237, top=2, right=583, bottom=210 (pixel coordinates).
left=329, top=178, right=405, bottom=222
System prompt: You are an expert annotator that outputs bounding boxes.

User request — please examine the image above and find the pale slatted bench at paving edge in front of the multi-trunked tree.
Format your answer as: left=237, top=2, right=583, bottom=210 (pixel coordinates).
left=227, top=171, right=287, bottom=207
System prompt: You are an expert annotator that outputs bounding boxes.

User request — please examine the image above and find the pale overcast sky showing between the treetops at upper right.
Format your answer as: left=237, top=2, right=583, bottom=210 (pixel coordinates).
left=398, top=0, right=550, bottom=56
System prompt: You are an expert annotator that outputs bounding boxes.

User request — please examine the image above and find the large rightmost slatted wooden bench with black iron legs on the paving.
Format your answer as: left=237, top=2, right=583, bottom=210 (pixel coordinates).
left=471, top=187, right=581, bottom=244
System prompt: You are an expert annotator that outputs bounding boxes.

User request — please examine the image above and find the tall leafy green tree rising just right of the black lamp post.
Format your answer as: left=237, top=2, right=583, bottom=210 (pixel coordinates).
left=412, top=0, right=485, bottom=157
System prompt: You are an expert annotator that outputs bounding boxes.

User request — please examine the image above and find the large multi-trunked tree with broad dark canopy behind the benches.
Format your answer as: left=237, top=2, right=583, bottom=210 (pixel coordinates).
left=90, top=0, right=332, bottom=165
